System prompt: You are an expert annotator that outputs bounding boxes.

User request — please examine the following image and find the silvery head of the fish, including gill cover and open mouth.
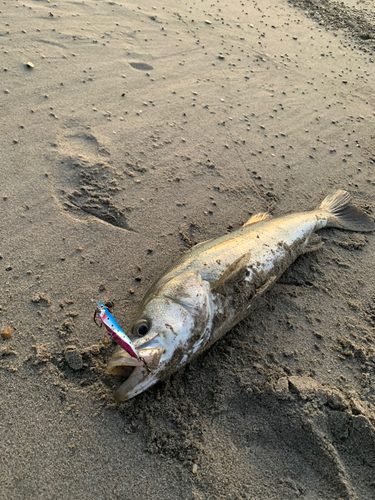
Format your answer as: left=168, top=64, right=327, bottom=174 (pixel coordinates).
left=107, top=272, right=213, bottom=401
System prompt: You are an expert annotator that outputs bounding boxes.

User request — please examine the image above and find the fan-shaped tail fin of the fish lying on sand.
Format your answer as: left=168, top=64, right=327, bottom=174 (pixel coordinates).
left=318, top=189, right=375, bottom=232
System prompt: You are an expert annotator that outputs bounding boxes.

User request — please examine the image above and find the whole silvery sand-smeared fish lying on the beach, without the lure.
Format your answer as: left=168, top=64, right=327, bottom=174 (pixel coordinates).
left=106, top=190, right=375, bottom=402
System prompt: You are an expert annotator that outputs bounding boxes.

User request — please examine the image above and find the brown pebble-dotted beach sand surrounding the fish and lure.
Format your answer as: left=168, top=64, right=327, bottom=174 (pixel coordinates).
left=0, top=0, right=375, bottom=500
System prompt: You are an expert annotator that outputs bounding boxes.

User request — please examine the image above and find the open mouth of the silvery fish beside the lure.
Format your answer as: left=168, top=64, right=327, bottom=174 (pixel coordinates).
left=106, top=345, right=164, bottom=402
